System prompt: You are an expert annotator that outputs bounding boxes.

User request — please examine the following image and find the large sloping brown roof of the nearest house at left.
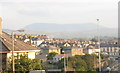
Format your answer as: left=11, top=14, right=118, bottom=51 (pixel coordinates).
left=0, top=32, right=40, bottom=51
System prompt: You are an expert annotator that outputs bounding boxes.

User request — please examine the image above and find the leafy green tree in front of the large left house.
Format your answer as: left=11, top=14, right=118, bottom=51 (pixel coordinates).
left=9, top=55, right=45, bottom=72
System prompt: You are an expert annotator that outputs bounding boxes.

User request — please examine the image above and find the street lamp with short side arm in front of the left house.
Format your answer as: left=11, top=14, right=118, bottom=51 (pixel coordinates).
left=12, top=30, right=24, bottom=73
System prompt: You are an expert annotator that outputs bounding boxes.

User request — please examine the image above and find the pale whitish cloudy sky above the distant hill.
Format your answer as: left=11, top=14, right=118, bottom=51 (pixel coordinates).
left=0, top=0, right=119, bottom=30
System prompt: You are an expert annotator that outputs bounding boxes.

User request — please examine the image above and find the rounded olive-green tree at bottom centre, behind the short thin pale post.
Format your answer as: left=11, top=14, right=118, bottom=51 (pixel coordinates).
left=57, top=56, right=87, bottom=71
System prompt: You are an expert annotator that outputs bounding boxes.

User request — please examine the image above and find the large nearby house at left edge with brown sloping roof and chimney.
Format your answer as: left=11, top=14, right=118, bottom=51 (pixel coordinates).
left=0, top=19, right=40, bottom=70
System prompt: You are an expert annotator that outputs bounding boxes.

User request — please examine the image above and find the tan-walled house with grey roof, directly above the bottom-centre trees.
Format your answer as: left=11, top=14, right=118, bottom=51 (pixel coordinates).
left=63, top=46, right=84, bottom=56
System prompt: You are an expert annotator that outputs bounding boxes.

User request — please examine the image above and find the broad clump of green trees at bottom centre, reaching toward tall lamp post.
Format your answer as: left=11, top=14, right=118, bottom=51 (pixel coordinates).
left=56, top=54, right=97, bottom=71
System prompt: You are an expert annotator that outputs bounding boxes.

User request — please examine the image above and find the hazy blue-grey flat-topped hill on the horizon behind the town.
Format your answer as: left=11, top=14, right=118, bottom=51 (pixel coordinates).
left=2, top=23, right=118, bottom=38
